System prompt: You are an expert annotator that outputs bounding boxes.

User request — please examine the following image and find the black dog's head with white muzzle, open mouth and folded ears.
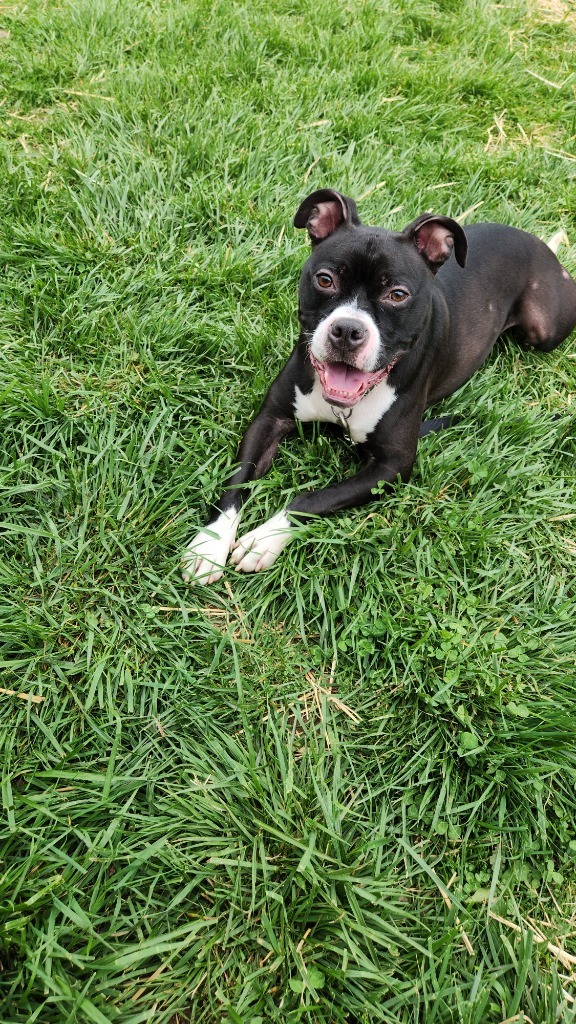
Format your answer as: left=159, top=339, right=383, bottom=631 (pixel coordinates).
left=294, top=188, right=466, bottom=407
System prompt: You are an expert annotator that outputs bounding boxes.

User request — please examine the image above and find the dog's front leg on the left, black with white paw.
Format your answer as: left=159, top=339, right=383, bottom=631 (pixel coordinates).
left=181, top=402, right=294, bottom=583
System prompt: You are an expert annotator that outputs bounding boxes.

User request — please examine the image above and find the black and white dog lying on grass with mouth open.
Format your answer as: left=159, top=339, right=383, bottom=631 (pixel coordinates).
left=182, top=188, right=576, bottom=584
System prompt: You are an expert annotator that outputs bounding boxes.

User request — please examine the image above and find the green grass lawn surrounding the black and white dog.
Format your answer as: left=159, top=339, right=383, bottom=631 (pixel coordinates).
left=0, top=0, right=576, bottom=1024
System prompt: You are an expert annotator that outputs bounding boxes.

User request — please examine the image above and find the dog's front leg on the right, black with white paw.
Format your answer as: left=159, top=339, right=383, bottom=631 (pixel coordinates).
left=232, top=446, right=415, bottom=572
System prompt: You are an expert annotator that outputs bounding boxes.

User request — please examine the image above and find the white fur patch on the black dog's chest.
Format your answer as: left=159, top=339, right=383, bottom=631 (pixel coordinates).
left=294, top=377, right=396, bottom=444
